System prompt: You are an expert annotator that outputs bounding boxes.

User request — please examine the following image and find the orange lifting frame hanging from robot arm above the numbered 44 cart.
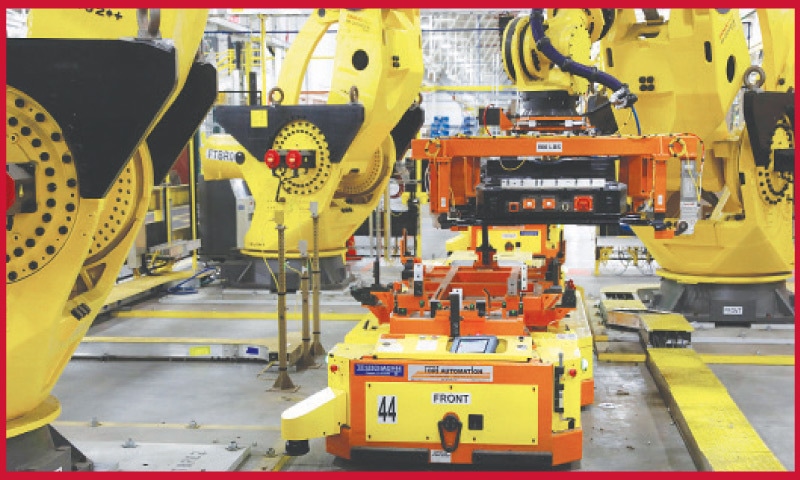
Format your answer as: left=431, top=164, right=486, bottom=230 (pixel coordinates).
left=411, top=134, right=701, bottom=217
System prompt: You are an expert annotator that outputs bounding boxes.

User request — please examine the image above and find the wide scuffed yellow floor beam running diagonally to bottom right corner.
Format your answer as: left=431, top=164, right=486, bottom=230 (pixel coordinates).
left=648, top=348, right=785, bottom=471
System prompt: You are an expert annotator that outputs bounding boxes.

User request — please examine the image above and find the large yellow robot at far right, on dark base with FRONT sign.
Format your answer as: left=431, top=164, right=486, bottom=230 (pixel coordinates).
left=601, top=9, right=794, bottom=320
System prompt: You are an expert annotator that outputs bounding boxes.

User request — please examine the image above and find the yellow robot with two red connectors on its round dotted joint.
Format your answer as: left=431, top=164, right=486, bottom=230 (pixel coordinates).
left=203, top=9, right=422, bottom=270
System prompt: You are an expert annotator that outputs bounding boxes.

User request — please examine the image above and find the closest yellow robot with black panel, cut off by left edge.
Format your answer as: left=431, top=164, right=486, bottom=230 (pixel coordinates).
left=6, top=9, right=216, bottom=450
